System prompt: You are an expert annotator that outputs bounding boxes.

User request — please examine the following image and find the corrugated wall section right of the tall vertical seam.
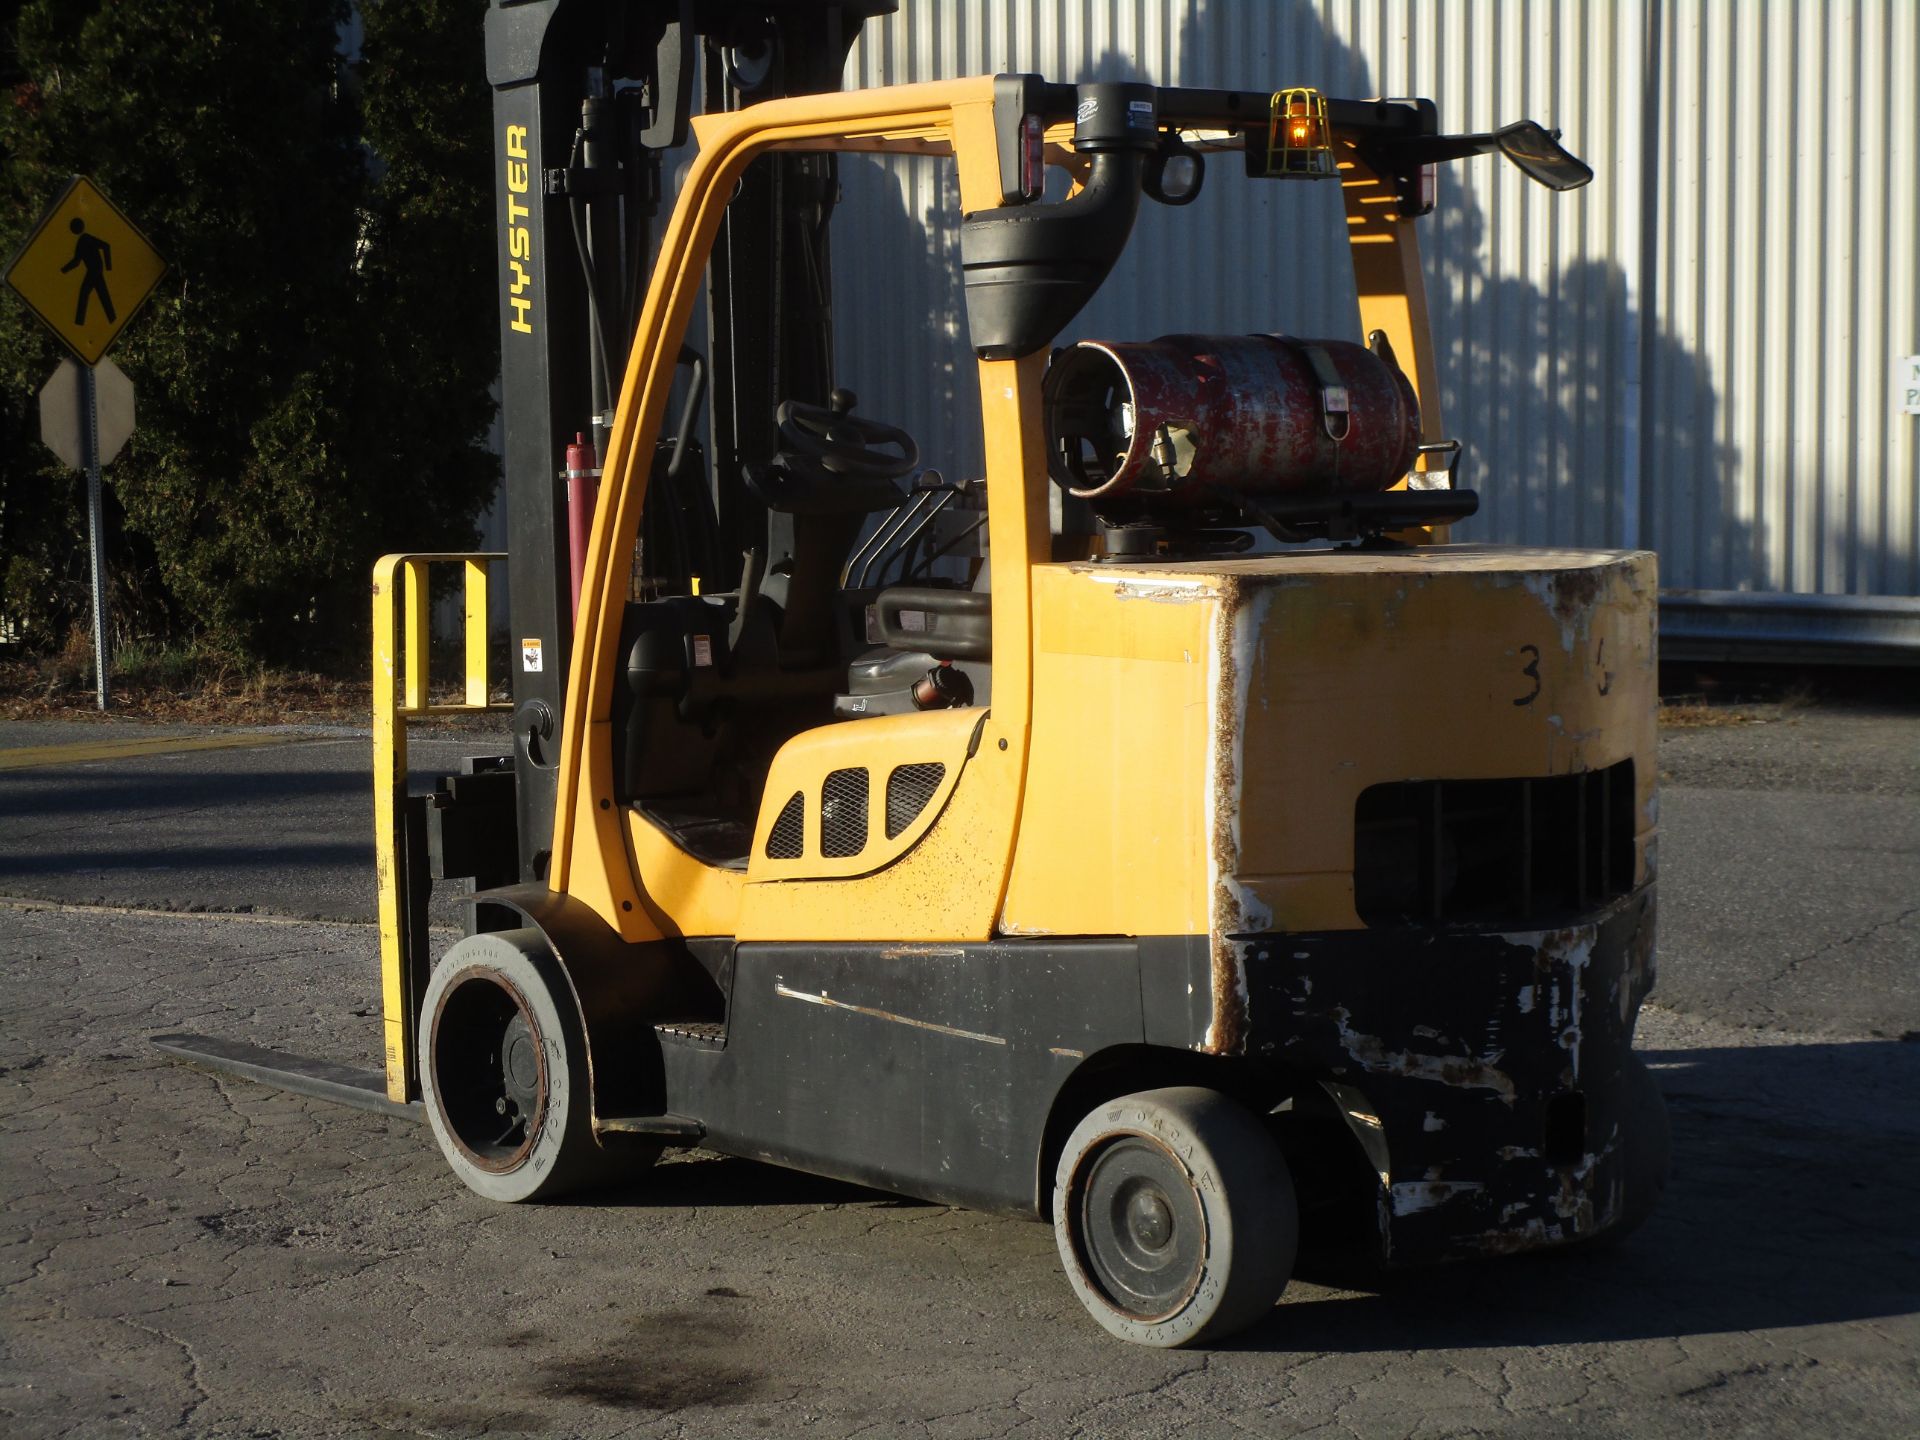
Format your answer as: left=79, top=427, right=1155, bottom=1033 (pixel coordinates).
left=1647, top=0, right=1920, bottom=595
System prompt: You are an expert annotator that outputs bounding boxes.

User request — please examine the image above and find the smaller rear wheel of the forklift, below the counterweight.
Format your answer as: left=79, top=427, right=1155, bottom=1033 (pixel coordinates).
left=1054, top=1087, right=1300, bottom=1346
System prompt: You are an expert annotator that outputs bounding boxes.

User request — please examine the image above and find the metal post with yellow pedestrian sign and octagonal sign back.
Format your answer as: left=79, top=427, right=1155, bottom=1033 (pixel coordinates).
left=6, top=175, right=167, bottom=710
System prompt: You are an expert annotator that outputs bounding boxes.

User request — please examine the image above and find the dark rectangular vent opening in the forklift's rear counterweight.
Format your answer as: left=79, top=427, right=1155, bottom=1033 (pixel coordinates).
left=1354, top=760, right=1634, bottom=925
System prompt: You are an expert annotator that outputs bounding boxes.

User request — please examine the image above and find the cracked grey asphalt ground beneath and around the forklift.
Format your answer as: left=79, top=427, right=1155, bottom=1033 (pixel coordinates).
left=0, top=712, right=1920, bottom=1440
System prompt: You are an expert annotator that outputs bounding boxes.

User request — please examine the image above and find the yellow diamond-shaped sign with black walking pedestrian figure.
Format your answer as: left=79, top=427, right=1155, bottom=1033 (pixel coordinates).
left=6, top=175, right=167, bottom=365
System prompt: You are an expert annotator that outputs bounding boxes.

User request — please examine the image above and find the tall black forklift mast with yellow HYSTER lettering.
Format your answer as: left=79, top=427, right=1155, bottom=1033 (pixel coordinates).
left=486, top=0, right=899, bottom=881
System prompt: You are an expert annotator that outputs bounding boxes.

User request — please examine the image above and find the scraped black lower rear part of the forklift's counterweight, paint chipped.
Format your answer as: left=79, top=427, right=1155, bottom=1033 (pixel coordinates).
left=1235, top=887, right=1653, bottom=1263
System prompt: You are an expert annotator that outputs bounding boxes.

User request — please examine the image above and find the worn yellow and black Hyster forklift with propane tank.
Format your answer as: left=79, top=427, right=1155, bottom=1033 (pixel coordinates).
left=175, top=0, right=1667, bottom=1346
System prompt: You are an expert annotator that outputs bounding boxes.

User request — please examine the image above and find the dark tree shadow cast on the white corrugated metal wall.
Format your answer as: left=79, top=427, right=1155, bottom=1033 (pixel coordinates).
left=835, top=0, right=1763, bottom=572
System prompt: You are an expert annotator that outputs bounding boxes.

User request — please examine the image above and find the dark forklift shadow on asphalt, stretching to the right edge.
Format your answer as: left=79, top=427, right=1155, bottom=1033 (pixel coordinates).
left=1223, top=1041, right=1920, bottom=1354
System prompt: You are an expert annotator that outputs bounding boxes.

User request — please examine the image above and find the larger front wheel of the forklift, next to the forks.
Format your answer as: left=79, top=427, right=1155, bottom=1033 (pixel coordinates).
left=420, top=929, right=624, bottom=1202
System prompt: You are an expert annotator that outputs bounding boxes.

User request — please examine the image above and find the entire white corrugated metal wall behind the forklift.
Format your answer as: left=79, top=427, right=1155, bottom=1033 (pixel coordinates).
left=833, top=0, right=1920, bottom=610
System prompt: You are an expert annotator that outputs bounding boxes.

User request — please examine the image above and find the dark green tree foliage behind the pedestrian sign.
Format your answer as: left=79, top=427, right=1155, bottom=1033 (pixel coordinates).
left=0, top=0, right=499, bottom=664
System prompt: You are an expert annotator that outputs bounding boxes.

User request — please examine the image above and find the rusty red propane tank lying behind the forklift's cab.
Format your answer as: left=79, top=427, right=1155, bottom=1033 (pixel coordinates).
left=1044, top=334, right=1421, bottom=515
